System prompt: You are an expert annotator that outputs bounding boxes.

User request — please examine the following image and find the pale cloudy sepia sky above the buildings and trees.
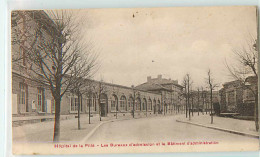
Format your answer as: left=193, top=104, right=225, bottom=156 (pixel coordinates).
left=74, top=7, right=257, bottom=87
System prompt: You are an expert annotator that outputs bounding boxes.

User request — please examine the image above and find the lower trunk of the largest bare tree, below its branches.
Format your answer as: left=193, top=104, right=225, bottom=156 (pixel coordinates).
left=53, top=98, right=61, bottom=142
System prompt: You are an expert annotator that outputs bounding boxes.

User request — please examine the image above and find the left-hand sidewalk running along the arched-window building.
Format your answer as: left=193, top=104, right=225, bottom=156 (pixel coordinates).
left=12, top=111, right=179, bottom=143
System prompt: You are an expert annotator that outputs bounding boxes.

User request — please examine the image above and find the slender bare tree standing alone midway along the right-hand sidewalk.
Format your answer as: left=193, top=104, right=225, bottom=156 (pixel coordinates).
left=207, top=69, right=218, bottom=124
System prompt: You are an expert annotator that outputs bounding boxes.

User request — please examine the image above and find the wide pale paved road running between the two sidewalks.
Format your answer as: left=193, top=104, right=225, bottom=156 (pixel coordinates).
left=85, top=115, right=258, bottom=145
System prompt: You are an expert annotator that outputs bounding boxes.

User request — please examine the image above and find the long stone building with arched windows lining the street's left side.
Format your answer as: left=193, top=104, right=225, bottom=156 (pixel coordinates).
left=12, top=11, right=183, bottom=116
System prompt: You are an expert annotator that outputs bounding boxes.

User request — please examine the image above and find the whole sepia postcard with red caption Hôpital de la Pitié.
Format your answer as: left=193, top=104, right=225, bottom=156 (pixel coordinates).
left=10, top=6, right=259, bottom=155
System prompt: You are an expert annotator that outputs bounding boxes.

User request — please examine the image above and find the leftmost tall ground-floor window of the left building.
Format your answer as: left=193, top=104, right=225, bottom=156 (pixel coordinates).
left=19, top=83, right=29, bottom=112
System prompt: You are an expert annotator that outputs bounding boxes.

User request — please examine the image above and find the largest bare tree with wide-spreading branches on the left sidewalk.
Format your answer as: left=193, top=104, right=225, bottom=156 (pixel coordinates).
left=14, top=10, right=97, bottom=141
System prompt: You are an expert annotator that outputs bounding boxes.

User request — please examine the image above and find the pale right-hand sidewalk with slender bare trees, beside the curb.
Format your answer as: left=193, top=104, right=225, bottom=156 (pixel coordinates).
left=176, top=112, right=259, bottom=138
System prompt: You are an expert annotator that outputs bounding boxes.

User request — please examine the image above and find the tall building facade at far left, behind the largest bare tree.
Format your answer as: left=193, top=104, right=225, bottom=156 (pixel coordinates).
left=11, top=11, right=57, bottom=115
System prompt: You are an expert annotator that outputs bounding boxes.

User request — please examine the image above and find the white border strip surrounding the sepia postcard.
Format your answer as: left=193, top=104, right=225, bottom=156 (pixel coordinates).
left=0, top=0, right=260, bottom=157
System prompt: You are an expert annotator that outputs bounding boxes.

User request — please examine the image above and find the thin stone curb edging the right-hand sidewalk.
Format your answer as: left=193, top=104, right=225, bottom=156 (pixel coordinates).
left=176, top=120, right=259, bottom=139
